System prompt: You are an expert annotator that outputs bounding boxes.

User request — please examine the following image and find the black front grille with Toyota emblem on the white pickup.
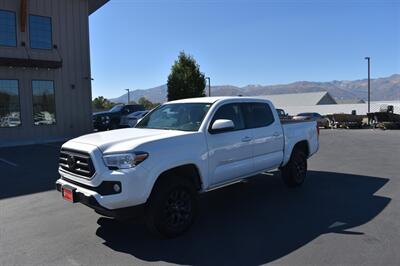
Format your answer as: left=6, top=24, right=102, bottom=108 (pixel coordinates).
left=59, top=149, right=95, bottom=178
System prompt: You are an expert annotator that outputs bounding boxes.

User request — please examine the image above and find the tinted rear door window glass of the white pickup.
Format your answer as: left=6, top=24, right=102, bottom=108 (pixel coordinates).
left=243, top=103, right=275, bottom=128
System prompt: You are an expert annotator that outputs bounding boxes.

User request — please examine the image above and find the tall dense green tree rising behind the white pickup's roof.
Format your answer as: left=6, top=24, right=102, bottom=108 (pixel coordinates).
left=167, top=52, right=206, bottom=101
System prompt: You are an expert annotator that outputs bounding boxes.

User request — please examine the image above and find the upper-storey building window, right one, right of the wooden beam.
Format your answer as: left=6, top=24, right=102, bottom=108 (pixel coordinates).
left=29, top=15, right=53, bottom=49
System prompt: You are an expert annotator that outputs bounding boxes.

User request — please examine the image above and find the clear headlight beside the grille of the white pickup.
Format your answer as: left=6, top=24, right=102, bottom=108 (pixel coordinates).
left=103, top=152, right=149, bottom=169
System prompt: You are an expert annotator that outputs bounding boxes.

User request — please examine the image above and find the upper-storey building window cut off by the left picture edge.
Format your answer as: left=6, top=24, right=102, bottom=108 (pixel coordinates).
left=0, top=10, right=17, bottom=46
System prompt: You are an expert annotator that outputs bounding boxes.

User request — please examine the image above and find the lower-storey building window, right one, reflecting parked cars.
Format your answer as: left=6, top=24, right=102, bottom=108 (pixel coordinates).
left=32, top=80, right=56, bottom=126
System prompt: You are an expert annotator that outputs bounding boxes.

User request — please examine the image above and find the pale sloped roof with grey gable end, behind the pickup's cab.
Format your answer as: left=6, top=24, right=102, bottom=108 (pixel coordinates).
left=256, top=91, right=337, bottom=107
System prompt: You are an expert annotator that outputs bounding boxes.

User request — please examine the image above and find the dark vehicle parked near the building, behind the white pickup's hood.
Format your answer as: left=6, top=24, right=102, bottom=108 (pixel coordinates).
left=93, top=104, right=145, bottom=131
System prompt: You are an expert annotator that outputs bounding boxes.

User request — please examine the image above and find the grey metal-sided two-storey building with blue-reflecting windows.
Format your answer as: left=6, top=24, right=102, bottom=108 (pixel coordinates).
left=0, top=0, right=108, bottom=146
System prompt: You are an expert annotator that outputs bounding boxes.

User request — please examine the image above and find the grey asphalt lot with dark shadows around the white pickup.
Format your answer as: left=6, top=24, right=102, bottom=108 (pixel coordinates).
left=0, top=130, right=400, bottom=265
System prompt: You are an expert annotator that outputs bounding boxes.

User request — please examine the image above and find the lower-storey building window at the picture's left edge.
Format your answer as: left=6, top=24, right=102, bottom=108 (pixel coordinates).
left=0, top=80, right=21, bottom=127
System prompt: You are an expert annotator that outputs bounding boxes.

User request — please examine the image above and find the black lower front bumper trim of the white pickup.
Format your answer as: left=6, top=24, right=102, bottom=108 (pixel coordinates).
left=56, top=179, right=145, bottom=218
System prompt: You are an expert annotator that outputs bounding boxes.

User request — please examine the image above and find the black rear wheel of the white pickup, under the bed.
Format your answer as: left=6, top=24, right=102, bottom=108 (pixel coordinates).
left=281, top=149, right=307, bottom=187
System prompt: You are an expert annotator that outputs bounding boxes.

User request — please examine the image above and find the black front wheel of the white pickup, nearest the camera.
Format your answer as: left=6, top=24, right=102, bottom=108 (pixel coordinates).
left=145, top=177, right=197, bottom=238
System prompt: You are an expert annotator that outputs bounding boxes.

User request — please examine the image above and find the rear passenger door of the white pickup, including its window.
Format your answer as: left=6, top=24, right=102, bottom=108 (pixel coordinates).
left=243, top=102, right=284, bottom=172
